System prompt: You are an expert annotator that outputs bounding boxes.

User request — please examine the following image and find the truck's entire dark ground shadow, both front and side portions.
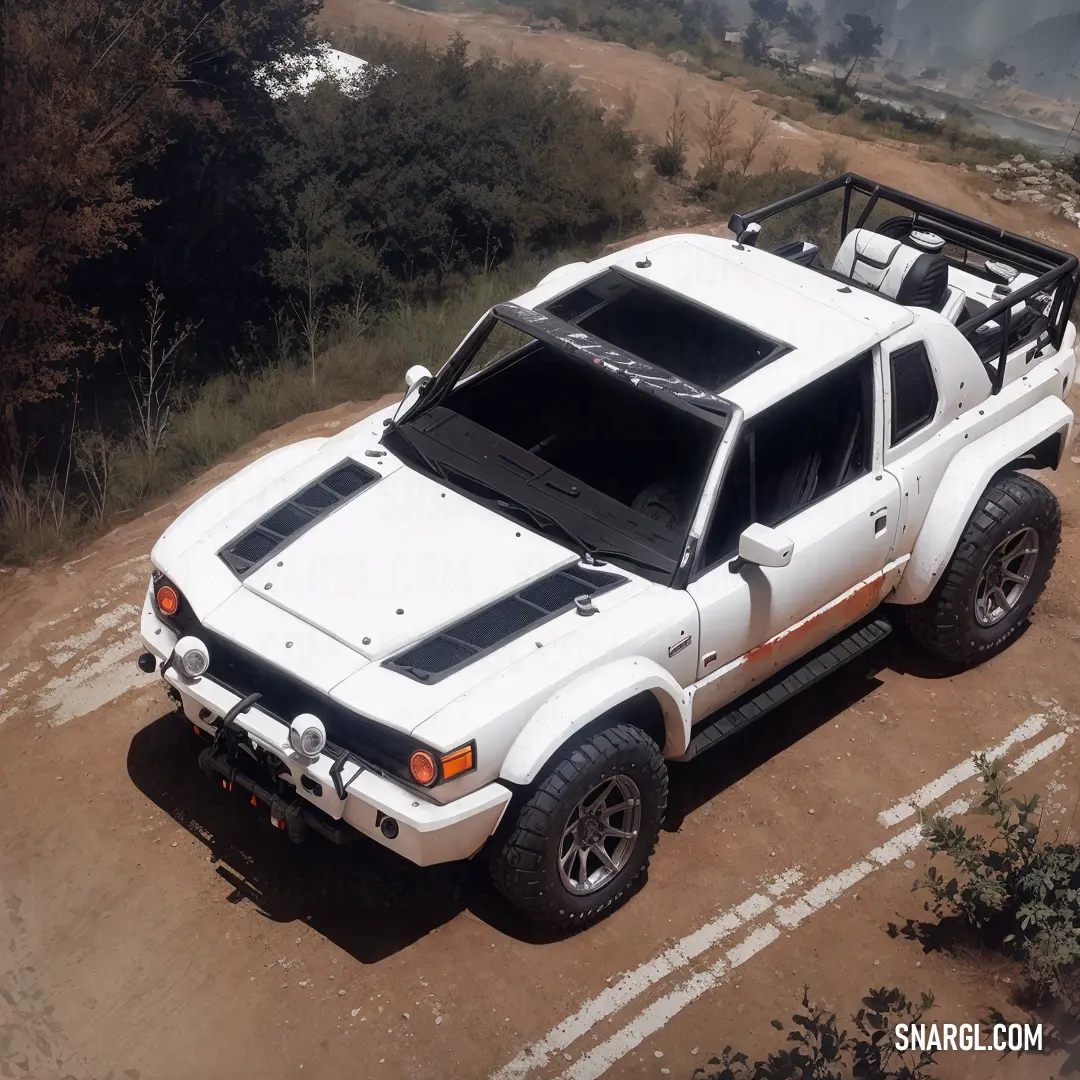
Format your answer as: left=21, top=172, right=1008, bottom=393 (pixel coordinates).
left=127, top=635, right=953, bottom=963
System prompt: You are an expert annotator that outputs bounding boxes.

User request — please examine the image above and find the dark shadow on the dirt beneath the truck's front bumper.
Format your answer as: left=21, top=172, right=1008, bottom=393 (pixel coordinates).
left=127, top=713, right=565, bottom=963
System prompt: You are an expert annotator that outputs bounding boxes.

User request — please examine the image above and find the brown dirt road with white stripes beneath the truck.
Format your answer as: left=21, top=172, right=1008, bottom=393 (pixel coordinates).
left=0, top=373, right=1080, bottom=1080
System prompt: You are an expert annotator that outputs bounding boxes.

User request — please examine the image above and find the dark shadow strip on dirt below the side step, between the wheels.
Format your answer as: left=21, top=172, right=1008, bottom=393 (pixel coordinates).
left=664, top=632, right=958, bottom=833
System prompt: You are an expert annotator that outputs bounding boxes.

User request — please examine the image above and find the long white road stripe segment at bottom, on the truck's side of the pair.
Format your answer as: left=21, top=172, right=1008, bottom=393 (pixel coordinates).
left=491, top=868, right=802, bottom=1080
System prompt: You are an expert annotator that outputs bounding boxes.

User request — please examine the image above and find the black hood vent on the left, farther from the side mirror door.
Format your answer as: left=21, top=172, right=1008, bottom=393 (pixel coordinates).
left=218, top=460, right=379, bottom=578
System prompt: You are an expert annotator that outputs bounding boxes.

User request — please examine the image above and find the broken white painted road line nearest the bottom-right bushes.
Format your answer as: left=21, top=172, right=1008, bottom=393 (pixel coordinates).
left=558, top=732, right=1067, bottom=1080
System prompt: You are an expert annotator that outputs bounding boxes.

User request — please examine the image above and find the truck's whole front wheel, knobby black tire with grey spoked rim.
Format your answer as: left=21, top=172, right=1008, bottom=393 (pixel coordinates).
left=489, top=724, right=667, bottom=927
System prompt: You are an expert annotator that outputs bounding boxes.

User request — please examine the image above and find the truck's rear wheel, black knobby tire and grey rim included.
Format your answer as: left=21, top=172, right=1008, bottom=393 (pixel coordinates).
left=907, top=473, right=1062, bottom=664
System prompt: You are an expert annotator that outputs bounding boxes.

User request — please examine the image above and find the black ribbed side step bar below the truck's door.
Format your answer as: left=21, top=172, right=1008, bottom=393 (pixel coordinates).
left=679, top=616, right=892, bottom=761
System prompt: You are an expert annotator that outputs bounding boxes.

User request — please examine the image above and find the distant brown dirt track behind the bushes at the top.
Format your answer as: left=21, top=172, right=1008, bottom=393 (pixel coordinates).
left=322, top=0, right=1080, bottom=261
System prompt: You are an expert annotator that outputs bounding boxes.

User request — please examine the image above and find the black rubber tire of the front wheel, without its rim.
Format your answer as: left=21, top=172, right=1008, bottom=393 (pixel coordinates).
left=488, top=724, right=667, bottom=928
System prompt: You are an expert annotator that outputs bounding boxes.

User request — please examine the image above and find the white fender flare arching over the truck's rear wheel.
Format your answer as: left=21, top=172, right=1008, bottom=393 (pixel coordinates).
left=889, top=397, right=1072, bottom=604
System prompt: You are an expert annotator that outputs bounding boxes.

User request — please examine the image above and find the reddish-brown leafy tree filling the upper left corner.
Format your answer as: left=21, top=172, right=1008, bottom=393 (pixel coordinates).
left=0, top=0, right=319, bottom=476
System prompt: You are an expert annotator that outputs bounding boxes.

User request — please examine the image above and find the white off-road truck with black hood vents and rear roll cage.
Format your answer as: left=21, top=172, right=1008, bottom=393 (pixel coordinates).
left=139, top=175, right=1078, bottom=926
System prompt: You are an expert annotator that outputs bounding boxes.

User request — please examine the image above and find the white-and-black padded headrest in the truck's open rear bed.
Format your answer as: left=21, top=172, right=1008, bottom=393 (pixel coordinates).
left=833, top=229, right=948, bottom=311
